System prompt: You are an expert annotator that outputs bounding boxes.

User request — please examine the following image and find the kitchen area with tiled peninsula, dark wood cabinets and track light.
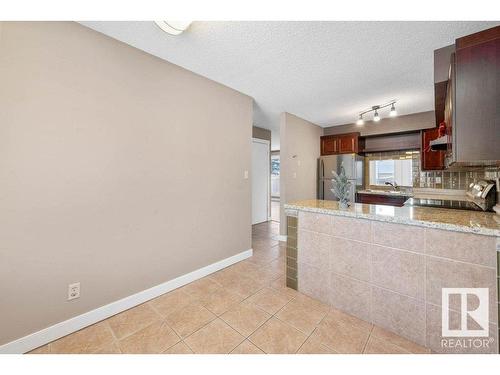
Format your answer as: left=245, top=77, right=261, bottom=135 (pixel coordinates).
left=284, top=27, right=500, bottom=353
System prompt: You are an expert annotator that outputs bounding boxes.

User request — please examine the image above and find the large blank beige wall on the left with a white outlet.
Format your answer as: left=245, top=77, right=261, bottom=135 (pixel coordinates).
left=0, top=22, right=252, bottom=344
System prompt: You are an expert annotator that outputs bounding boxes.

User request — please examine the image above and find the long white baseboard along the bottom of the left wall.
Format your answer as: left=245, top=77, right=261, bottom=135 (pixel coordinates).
left=0, top=249, right=253, bottom=354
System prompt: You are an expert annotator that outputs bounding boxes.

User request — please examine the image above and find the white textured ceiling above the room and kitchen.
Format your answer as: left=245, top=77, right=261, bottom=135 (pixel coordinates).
left=81, top=21, right=500, bottom=148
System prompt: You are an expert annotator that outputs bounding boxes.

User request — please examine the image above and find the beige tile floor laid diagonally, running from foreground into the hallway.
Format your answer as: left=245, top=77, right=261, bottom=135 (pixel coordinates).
left=26, top=222, right=428, bottom=354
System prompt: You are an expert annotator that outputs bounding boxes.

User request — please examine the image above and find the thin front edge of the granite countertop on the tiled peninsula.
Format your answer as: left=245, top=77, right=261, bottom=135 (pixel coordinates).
left=284, top=204, right=500, bottom=237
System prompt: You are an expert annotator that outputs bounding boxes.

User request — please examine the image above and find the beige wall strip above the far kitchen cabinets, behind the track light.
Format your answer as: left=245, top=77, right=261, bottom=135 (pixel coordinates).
left=324, top=111, right=436, bottom=136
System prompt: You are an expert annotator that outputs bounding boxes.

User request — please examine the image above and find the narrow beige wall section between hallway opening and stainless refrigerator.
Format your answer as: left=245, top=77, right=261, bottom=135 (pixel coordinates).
left=280, top=112, right=323, bottom=235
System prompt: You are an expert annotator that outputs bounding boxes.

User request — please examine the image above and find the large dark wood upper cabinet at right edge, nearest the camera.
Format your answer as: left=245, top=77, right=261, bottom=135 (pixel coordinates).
left=451, top=26, right=500, bottom=163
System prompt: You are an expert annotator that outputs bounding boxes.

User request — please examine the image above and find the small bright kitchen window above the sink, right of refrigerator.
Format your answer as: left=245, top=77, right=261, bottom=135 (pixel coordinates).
left=369, top=158, right=413, bottom=186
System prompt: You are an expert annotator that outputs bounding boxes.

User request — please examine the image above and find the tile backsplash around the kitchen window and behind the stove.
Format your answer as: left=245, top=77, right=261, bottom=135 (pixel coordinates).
left=365, top=150, right=500, bottom=190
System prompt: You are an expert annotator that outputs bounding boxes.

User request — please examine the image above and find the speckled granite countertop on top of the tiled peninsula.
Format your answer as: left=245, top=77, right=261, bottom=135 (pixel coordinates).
left=285, top=199, right=500, bottom=237
